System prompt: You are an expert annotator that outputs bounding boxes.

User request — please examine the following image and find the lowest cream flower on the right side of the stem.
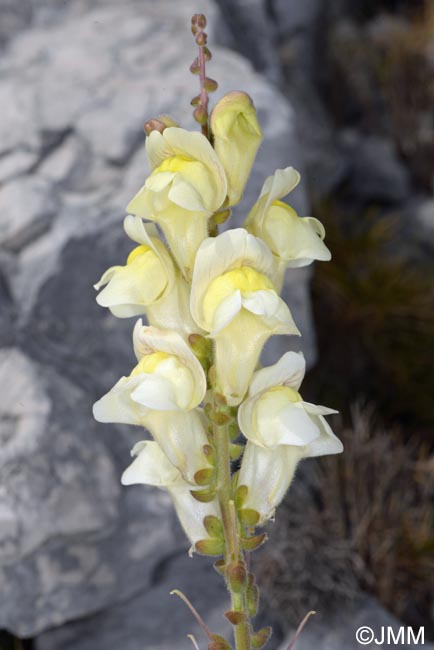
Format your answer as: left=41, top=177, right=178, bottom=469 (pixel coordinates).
left=238, top=352, right=343, bottom=524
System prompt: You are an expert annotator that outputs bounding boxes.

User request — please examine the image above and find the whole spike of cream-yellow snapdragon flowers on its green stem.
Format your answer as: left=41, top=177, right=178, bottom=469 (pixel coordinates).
left=94, top=15, right=342, bottom=648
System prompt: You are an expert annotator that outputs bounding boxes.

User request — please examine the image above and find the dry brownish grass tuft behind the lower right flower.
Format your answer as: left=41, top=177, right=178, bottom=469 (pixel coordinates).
left=260, top=409, right=434, bottom=634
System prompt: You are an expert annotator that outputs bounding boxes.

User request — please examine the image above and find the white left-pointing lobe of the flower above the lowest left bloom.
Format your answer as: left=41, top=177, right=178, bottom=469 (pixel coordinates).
left=93, top=376, right=147, bottom=425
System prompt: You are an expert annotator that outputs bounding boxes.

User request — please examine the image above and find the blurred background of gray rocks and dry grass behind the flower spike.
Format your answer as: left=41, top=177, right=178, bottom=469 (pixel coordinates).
left=0, top=0, right=434, bottom=650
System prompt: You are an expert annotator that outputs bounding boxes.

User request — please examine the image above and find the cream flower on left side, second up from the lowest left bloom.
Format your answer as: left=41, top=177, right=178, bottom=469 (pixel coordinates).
left=94, top=216, right=198, bottom=335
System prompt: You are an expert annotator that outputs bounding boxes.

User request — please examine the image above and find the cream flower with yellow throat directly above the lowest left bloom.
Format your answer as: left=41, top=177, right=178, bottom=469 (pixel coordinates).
left=93, top=320, right=210, bottom=480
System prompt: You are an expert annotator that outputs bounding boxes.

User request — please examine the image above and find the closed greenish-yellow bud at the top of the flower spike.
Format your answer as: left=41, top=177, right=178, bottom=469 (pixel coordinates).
left=210, top=91, right=262, bottom=206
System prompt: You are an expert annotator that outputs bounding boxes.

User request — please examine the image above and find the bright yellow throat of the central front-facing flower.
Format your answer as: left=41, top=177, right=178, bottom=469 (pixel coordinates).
left=203, top=266, right=275, bottom=323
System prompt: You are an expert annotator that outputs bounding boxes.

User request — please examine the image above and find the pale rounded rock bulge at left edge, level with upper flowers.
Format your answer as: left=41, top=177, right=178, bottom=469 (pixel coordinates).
left=0, top=176, right=57, bottom=251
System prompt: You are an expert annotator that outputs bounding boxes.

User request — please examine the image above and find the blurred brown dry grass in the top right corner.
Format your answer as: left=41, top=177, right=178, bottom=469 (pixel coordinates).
left=330, top=1, right=434, bottom=191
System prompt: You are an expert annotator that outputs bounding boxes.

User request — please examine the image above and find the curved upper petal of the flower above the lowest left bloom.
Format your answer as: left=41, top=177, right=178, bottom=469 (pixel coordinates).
left=133, top=320, right=206, bottom=409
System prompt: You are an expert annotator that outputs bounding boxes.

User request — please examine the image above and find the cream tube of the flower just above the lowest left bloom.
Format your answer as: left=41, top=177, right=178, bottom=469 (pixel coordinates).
left=145, top=409, right=210, bottom=488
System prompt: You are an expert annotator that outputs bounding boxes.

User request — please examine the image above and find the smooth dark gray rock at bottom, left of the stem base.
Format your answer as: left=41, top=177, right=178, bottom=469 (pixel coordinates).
left=36, top=551, right=234, bottom=650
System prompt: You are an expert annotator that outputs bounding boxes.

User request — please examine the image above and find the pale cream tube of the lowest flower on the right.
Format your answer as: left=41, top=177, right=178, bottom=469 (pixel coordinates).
left=238, top=442, right=300, bottom=524
